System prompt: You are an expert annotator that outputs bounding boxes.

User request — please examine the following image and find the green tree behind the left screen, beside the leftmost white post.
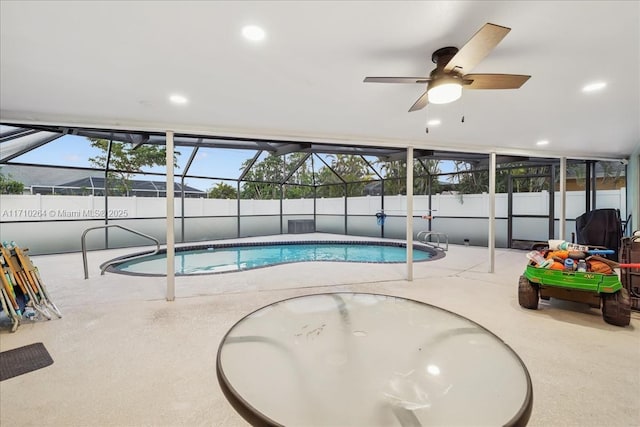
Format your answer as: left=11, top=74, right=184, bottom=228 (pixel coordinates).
left=89, top=138, right=180, bottom=196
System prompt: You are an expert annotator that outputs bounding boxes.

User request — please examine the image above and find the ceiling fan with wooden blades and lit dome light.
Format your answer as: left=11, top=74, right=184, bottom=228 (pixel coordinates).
left=364, top=23, right=531, bottom=112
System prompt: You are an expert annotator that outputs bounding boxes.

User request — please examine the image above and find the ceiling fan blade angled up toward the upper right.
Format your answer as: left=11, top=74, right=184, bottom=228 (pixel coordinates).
left=444, top=24, right=511, bottom=73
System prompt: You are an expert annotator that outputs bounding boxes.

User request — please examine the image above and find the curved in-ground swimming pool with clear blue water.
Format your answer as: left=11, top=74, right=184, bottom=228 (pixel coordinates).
left=105, top=241, right=444, bottom=276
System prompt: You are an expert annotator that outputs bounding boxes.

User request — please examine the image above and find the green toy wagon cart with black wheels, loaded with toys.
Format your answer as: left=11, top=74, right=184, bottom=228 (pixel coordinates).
left=518, top=240, right=640, bottom=326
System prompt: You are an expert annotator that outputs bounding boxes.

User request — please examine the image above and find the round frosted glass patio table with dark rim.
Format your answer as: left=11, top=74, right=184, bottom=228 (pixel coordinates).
left=216, top=293, right=533, bottom=426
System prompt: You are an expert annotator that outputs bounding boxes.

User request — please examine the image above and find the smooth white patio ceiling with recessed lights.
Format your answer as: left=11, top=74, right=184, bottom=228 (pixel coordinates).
left=0, top=1, right=640, bottom=158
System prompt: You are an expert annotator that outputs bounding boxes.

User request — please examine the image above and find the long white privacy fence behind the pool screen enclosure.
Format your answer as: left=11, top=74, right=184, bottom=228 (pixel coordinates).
left=0, top=188, right=626, bottom=254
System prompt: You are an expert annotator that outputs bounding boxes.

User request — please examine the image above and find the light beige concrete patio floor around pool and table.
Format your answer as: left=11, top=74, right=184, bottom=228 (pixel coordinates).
left=0, top=234, right=640, bottom=427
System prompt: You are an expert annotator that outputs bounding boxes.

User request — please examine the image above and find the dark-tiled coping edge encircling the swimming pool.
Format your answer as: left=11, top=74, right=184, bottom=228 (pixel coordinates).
left=100, top=240, right=446, bottom=277
